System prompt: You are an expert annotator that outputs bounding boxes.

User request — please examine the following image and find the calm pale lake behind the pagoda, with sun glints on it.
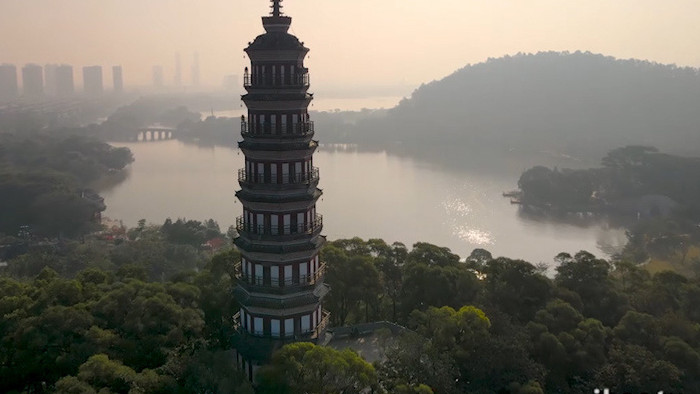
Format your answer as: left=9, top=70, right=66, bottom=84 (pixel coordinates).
left=101, top=141, right=625, bottom=263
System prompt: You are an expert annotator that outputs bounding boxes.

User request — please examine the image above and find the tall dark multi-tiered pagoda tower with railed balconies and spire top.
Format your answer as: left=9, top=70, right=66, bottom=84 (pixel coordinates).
left=235, top=0, right=329, bottom=379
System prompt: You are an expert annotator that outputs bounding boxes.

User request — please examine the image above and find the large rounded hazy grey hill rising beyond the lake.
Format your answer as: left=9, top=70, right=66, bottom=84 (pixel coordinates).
left=340, top=52, right=700, bottom=157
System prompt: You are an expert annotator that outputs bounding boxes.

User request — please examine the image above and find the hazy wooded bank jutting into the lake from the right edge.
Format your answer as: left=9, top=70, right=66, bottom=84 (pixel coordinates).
left=517, top=146, right=700, bottom=275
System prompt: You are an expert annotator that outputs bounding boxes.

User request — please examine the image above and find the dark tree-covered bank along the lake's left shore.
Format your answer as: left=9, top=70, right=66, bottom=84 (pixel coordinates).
left=0, top=134, right=133, bottom=237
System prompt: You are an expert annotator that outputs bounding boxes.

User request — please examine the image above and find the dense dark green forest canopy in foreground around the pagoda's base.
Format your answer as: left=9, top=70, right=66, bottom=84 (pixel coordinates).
left=0, top=232, right=700, bottom=394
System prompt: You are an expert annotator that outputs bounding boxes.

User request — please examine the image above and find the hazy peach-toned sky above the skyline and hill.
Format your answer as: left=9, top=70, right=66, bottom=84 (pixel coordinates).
left=0, top=0, right=700, bottom=95
